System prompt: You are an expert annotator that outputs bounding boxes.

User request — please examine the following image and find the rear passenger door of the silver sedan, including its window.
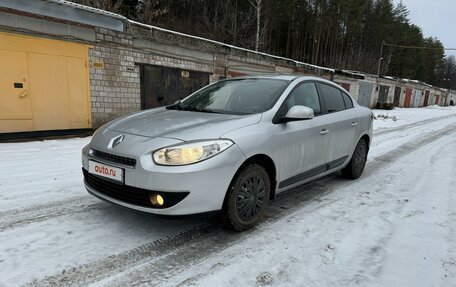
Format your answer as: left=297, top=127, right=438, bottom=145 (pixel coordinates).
left=318, top=83, right=359, bottom=169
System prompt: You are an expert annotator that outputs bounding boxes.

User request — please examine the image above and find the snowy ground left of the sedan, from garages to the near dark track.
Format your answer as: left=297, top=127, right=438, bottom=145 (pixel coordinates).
left=0, top=137, right=210, bottom=286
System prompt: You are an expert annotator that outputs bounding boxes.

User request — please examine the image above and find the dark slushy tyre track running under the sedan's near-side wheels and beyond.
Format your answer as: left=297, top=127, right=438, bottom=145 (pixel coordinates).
left=27, top=124, right=456, bottom=286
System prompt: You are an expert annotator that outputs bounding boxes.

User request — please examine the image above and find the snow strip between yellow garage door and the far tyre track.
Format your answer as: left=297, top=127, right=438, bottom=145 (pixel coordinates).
left=0, top=138, right=90, bottom=211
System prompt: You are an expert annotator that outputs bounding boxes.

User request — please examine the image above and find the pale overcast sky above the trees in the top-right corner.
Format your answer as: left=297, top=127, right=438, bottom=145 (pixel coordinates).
left=393, top=0, right=456, bottom=56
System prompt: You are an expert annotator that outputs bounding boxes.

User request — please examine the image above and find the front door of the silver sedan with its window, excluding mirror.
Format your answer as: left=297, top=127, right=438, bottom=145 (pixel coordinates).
left=269, top=82, right=330, bottom=188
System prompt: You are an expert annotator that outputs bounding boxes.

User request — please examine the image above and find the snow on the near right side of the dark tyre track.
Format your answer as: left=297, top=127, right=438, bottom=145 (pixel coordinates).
left=167, top=117, right=456, bottom=286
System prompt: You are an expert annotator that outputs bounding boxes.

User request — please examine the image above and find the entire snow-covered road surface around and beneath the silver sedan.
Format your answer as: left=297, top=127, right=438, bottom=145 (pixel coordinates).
left=0, top=109, right=456, bottom=286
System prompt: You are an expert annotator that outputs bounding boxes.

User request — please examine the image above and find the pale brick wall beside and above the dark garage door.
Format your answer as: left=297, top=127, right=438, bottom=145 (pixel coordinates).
left=89, top=28, right=218, bottom=128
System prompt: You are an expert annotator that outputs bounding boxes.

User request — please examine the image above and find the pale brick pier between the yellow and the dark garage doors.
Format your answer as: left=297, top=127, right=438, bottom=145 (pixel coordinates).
left=89, top=29, right=141, bottom=127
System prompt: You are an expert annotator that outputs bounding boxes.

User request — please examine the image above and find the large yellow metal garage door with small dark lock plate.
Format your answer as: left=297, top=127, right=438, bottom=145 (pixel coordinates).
left=0, top=33, right=91, bottom=133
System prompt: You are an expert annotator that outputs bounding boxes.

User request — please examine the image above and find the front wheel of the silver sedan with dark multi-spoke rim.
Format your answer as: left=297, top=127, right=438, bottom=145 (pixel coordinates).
left=222, top=164, right=271, bottom=231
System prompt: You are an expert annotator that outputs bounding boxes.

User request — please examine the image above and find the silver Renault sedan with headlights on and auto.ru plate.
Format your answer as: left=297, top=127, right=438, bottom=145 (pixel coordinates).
left=82, top=76, right=373, bottom=231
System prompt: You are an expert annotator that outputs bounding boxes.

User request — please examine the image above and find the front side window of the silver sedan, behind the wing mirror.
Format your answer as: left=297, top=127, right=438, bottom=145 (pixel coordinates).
left=286, top=83, right=321, bottom=115
